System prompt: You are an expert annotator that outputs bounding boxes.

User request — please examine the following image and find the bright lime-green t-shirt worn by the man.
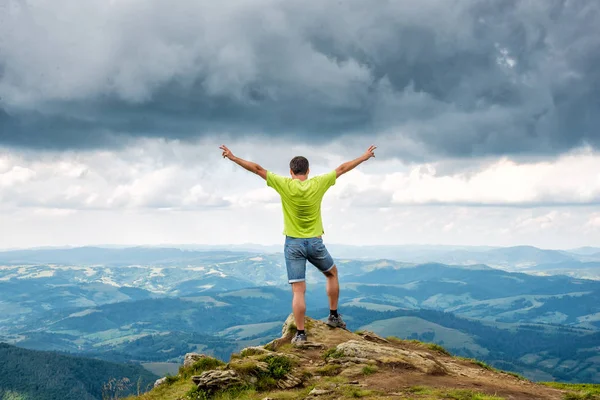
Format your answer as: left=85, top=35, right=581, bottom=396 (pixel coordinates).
left=267, top=170, right=336, bottom=238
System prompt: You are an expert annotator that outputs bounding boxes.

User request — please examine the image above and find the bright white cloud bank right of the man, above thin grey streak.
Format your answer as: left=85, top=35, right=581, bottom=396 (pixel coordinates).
left=332, top=150, right=600, bottom=206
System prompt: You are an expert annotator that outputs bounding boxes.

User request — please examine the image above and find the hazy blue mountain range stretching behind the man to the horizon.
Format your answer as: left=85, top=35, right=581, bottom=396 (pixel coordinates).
left=0, top=247, right=600, bottom=382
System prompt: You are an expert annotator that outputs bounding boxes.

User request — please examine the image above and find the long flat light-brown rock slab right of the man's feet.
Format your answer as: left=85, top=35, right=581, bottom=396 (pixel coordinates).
left=336, top=340, right=438, bottom=372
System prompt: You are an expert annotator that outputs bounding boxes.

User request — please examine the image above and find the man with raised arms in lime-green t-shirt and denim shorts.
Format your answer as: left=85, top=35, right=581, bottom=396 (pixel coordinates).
left=219, top=145, right=376, bottom=344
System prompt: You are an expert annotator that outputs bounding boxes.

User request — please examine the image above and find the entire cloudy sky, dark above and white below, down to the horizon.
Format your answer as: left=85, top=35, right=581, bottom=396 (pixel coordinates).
left=0, top=0, right=600, bottom=249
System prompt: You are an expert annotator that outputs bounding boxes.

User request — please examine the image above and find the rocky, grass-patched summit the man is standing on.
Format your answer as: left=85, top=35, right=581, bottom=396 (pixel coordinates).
left=131, top=315, right=595, bottom=400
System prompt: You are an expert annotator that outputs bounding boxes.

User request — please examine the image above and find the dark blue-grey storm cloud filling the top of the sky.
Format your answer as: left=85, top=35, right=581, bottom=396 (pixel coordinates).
left=0, top=0, right=600, bottom=157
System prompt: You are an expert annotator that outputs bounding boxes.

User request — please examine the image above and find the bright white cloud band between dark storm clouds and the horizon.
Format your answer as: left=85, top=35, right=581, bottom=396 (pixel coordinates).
left=0, top=139, right=600, bottom=248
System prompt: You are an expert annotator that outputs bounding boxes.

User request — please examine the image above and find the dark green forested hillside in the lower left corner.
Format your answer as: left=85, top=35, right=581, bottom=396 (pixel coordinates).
left=0, top=343, right=157, bottom=400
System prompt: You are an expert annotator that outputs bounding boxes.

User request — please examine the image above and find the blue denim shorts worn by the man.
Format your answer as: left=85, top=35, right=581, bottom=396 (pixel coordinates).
left=283, top=236, right=335, bottom=283
